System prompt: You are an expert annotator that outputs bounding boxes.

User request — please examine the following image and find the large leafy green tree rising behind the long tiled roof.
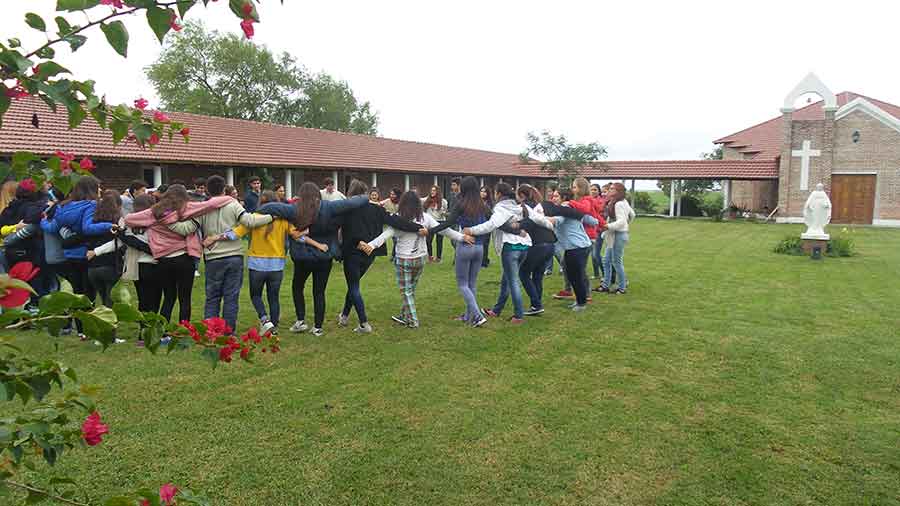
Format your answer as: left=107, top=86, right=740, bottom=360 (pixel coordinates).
left=146, top=22, right=378, bottom=135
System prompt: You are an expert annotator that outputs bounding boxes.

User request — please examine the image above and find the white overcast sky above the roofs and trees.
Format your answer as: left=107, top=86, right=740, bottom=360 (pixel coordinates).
left=0, top=0, right=900, bottom=188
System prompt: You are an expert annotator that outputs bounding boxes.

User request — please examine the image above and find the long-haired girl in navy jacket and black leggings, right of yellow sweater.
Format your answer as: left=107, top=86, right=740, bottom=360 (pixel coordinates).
left=257, top=182, right=369, bottom=336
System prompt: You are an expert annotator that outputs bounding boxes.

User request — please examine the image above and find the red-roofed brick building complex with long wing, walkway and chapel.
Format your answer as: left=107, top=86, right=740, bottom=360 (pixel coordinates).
left=0, top=74, right=900, bottom=226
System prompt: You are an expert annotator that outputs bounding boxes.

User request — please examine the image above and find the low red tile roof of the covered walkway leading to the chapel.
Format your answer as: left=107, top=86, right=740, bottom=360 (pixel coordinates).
left=519, top=159, right=778, bottom=179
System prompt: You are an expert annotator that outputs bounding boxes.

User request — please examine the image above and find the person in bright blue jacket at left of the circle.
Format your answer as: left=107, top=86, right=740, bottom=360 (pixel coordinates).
left=41, top=176, right=116, bottom=338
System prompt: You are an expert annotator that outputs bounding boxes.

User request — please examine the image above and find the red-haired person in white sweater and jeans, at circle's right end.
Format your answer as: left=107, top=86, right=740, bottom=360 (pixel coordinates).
left=600, top=183, right=634, bottom=294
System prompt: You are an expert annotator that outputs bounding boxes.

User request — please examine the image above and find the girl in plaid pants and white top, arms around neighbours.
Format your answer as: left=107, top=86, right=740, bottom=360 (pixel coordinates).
left=358, top=191, right=474, bottom=328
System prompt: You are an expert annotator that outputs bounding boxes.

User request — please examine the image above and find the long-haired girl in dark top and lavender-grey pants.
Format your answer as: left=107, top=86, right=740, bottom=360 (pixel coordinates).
left=429, top=176, right=491, bottom=327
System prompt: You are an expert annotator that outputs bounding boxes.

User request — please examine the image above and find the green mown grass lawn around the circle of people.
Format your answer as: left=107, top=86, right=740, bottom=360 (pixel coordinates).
left=4, top=218, right=900, bottom=506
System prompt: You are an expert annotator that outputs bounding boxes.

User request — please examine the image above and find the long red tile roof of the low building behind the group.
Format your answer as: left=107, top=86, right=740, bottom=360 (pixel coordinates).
left=0, top=97, right=520, bottom=176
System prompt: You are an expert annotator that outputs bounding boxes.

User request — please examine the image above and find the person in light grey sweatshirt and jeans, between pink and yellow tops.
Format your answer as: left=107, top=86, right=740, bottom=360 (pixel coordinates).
left=169, top=176, right=272, bottom=331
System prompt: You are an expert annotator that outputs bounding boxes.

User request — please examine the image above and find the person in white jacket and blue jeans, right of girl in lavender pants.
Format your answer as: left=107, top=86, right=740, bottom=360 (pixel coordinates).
left=463, top=183, right=546, bottom=324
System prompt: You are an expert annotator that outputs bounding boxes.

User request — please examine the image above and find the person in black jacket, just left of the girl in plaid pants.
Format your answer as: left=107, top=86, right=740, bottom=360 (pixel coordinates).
left=338, top=179, right=427, bottom=333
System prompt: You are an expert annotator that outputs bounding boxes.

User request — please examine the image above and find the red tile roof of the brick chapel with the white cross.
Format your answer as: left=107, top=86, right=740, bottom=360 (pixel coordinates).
left=713, top=91, right=900, bottom=159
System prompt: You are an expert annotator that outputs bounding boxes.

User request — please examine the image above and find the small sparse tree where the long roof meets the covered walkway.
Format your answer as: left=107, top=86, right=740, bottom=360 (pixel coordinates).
left=519, top=130, right=606, bottom=181
